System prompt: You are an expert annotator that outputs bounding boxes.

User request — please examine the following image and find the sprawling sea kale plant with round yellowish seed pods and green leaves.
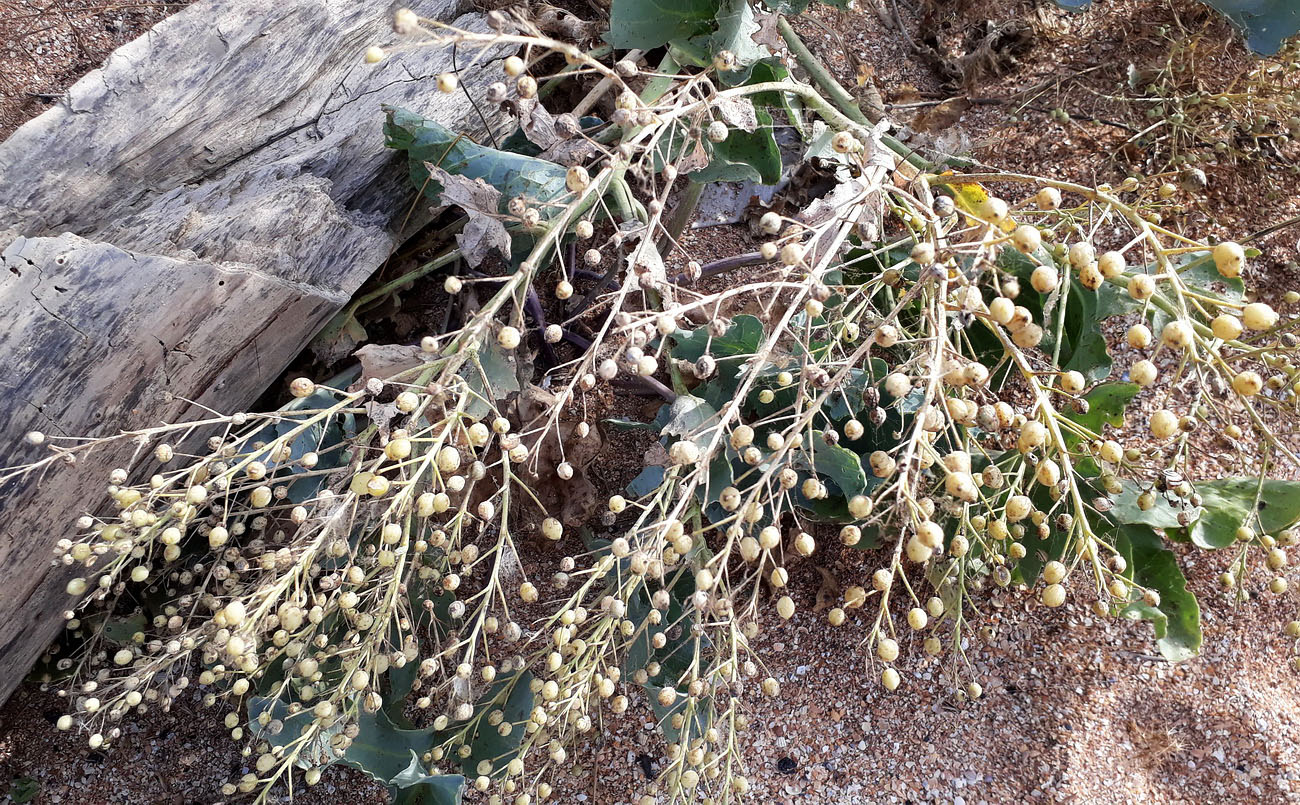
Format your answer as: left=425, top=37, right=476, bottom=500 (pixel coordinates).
left=3, top=0, right=1300, bottom=805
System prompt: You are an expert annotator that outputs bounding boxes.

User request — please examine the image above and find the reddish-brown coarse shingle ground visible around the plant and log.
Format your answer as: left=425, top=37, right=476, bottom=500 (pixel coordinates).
left=0, top=0, right=1300, bottom=805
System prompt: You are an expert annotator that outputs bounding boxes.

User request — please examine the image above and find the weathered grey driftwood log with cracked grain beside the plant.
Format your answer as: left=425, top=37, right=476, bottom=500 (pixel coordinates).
left=0, top=0, right=506, bottom=702
